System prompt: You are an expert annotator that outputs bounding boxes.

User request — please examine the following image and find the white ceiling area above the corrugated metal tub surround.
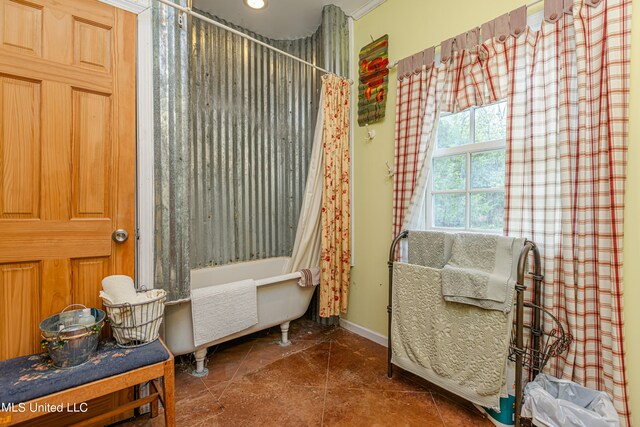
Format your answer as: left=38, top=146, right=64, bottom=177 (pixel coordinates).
left=193, top=0, right=382, bottom=40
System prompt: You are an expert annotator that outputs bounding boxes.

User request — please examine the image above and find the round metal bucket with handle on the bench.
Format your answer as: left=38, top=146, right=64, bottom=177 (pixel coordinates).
left=40, top=304, right=106, bottom=368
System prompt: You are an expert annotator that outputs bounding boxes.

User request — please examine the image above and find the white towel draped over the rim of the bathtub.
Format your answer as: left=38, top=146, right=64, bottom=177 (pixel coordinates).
left=191, top=280, right=258, bottom=347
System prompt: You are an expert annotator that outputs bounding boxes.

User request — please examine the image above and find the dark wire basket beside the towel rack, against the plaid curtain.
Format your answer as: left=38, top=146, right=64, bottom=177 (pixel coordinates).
left=509, top=303, right=573, bottom=372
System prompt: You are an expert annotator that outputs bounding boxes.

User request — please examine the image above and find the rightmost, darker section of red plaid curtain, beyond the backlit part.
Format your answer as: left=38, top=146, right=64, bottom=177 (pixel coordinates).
left=561, top=0, right=631, bottom=424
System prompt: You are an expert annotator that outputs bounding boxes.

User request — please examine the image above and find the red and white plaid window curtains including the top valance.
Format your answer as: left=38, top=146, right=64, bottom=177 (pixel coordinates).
left=394, top=0, right=631, bottom=425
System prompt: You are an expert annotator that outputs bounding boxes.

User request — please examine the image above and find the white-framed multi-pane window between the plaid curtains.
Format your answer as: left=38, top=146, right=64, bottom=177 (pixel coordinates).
left=426, top=101, right=507, bottom=232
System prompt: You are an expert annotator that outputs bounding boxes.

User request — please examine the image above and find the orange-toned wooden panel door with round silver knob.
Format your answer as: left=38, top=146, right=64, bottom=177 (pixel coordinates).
left=0, top=0, right=136, bottom=360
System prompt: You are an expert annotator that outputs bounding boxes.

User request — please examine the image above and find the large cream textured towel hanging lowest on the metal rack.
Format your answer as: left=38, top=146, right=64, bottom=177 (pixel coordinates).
left=391, top=263, right=514, bottom=407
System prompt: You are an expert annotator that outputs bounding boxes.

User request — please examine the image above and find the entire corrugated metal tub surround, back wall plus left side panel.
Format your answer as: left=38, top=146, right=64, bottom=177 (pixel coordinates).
left=154, top=0, right=349, bottom=300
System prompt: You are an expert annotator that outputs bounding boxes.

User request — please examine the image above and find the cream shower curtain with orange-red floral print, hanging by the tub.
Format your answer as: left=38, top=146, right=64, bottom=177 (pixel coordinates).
left=320, top=74, right=351, bottom=317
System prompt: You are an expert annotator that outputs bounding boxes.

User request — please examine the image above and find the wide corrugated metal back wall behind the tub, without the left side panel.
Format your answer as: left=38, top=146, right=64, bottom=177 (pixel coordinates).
left=191, top=6, right=348, bottom=268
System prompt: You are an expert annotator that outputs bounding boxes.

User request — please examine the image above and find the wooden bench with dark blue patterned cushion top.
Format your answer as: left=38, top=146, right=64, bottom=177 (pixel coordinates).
left=0, top=340, right=175, bottom=427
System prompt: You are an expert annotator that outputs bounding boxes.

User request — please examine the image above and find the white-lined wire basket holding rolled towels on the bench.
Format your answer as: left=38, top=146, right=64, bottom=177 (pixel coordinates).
left=103, top=289, right=167, bottom=348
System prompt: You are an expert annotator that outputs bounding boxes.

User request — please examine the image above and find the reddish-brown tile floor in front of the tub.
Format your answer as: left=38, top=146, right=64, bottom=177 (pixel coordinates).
left=121, top=319, right=492, bottom=427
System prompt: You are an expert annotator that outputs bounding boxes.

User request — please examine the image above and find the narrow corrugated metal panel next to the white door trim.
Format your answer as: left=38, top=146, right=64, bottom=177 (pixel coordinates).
left=152, top=0, right=191, bottom=301
